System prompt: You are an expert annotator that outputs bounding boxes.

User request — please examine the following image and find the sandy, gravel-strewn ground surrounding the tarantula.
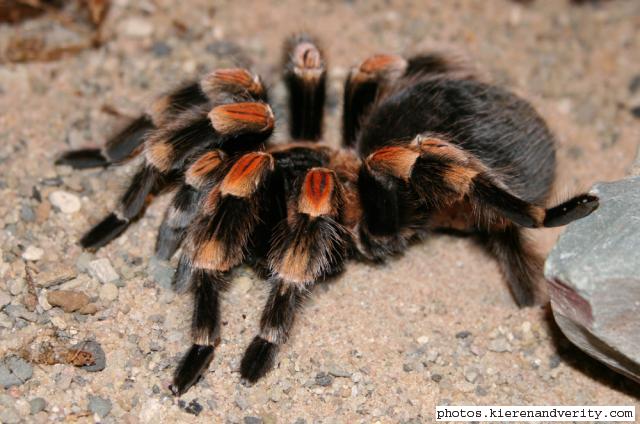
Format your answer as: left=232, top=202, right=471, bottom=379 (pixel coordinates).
left=0, top=0, right=640, bottom=424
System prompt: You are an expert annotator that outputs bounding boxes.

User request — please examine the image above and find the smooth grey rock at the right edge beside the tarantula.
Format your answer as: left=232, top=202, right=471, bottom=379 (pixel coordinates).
left=545, top=177, right=640, bottom=382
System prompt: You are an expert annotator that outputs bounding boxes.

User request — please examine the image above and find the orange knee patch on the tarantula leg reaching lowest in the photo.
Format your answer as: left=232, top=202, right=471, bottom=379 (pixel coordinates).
left=220, top=152, right=274, bottom=197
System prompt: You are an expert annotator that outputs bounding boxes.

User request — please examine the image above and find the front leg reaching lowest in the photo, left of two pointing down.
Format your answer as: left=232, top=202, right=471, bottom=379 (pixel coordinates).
left=171, top=152, right=274, bottom=395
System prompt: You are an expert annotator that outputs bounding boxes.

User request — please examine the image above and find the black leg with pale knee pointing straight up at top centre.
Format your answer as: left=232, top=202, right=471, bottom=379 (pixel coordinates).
left=284, top=35, right=327, bottom=141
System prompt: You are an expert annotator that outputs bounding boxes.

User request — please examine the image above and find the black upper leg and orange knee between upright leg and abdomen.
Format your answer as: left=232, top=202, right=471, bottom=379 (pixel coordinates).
left=342, top=54, right=407, bottom=147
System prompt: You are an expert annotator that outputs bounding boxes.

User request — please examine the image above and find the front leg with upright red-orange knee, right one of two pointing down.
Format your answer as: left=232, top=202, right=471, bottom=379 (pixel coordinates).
left=240, top=168, right=351, bottom=382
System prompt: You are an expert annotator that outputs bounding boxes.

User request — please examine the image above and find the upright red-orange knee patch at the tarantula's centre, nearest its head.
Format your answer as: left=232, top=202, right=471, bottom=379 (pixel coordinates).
left=298, top=168, right=335, bottom=216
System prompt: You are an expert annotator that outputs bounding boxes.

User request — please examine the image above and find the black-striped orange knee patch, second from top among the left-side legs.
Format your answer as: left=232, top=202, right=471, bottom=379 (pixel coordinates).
left=209, top=102, right=275, bottom=134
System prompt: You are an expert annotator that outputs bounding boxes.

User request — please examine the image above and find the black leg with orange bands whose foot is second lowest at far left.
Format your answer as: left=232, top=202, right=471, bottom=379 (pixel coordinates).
left=81, top=96, right=274, bottom=249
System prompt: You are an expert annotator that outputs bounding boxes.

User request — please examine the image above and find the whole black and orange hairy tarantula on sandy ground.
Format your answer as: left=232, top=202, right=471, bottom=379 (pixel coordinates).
left=58, top=32, right=598, bottom=395
